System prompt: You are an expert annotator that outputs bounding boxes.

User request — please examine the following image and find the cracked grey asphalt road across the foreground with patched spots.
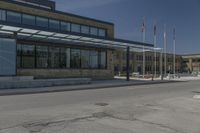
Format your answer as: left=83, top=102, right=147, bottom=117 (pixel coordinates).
left=0, top=81, right=200, bottom=133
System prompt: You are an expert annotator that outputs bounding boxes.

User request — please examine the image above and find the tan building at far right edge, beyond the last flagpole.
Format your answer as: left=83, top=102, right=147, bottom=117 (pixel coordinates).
left=182, top=54, right=200, bottom=72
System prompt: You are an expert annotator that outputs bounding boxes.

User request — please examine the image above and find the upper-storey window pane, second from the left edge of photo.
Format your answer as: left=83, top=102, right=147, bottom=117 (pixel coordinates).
left=7, top=11, right=21, bottom=23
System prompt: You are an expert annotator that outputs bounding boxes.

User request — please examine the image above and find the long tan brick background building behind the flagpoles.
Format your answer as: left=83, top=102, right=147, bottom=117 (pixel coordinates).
left=114, top=50, right=182, bottom=75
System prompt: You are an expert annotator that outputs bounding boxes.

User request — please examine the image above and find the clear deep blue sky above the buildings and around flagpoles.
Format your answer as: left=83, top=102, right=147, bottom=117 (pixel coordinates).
left=54, top=0, right=200, bottom=54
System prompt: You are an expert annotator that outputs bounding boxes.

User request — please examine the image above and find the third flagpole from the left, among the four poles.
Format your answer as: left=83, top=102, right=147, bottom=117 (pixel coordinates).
left=164, top=24, right=167, bottom=76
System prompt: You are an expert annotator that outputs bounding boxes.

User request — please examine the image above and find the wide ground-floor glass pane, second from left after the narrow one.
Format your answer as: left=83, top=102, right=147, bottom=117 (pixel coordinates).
left=22, top=45, right=35, bottom=68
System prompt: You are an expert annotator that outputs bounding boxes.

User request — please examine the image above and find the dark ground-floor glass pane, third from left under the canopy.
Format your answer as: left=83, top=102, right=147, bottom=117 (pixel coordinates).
left=36, top=46, right=48, bottom=68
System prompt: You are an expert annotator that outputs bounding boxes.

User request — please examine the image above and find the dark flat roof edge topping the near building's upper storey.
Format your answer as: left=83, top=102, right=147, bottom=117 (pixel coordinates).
left=6, top=0, right=114, bottom=25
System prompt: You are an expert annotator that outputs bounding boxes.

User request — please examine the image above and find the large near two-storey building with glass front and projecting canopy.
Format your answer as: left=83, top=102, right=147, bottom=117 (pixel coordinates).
left=0, top=0, right=153, bottom=79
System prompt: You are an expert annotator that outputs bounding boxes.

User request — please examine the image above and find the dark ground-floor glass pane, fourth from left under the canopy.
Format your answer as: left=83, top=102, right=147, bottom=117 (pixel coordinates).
left=49, top=47, right=60, bottom=68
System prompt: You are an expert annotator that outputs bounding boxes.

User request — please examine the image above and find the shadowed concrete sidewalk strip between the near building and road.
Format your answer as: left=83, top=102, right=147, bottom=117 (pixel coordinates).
left=0, top=79, right=181, bottom=96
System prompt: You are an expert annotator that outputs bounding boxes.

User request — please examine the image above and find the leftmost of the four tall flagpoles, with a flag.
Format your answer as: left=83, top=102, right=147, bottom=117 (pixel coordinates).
left=142, top=18, right=146, bottom=78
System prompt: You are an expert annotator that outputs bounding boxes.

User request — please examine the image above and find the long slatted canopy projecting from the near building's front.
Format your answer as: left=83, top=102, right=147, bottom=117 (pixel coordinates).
left=0, top=25, right=153, bottom=51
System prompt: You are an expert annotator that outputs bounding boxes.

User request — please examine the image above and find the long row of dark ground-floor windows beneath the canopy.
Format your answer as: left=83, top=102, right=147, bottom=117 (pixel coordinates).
left=17, top=44, right=107, bottom=69
